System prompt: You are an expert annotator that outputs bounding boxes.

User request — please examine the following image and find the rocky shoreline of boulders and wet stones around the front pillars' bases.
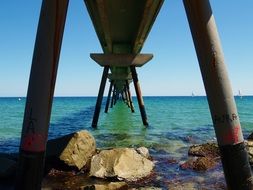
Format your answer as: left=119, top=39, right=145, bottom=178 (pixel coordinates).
left=0, top=131, right=253, bottom=190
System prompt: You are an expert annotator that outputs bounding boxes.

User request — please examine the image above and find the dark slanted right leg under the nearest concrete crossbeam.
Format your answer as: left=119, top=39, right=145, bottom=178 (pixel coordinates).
left=130, top=66, right=148, bottom=126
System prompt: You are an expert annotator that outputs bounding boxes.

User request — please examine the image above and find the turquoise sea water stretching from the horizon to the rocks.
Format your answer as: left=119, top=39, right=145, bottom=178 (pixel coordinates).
left=0, top=96, right=253, bottom=188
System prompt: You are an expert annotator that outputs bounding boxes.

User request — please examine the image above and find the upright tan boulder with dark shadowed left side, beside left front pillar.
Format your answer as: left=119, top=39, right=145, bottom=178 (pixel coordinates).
left=46, top=130, right=96, bottom=169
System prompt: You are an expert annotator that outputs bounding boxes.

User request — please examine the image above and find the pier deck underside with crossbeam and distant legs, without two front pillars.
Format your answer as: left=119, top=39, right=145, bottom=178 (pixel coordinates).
left=84, top=0, right=163, bottom=127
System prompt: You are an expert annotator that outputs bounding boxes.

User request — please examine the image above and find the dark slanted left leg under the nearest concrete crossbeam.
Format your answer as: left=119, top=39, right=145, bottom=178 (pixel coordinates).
left=92, top=66, right=109, bottom=128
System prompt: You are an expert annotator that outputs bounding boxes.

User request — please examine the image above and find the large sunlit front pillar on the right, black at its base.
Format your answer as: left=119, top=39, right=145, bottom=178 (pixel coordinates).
left=184, top=0, right=253, bottom=190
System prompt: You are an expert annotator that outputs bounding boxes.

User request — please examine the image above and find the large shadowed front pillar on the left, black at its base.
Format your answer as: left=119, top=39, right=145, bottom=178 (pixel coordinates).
left=15, top=0, right=68, bottom=189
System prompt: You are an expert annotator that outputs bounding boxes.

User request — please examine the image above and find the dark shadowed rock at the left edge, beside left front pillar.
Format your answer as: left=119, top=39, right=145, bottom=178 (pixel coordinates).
left=0, top=157, right=17, bottom=179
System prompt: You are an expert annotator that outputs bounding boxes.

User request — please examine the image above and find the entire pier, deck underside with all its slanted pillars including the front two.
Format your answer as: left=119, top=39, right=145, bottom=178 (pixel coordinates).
left=16, top=0, right=253, bottom=190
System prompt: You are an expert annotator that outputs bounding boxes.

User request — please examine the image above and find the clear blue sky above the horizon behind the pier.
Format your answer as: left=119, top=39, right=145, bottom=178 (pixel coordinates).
left=0, top=0, right=253, bottom=96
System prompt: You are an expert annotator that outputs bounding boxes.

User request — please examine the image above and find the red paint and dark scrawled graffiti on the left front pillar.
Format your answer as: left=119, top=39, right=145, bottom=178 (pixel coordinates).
left=22, top=108, right=45, bottom=152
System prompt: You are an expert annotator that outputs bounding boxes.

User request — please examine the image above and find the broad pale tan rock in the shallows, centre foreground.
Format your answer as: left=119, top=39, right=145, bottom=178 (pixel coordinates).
left=90, top=148, right=154, bottom=181
